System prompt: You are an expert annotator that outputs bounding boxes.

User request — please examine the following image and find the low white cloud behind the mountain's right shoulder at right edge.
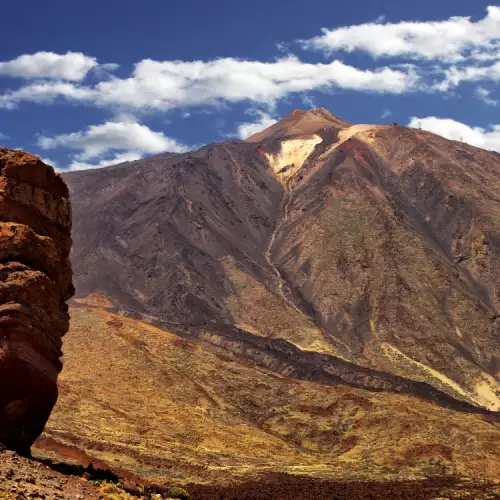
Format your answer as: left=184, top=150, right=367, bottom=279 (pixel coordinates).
left=408, top=116, right=500, bottom=152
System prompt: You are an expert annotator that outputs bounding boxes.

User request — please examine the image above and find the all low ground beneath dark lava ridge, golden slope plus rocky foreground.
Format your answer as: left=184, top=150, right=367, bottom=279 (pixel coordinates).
left=6, top=307, right=492, bottom=500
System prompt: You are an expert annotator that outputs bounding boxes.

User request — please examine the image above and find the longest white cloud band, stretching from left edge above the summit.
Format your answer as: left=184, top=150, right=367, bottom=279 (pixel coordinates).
left=0, top=56, right=418, bottom=111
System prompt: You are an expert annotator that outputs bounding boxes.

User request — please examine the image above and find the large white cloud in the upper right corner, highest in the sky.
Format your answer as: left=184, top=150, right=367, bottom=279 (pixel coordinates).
left=300, top=6, right=500, bottom=62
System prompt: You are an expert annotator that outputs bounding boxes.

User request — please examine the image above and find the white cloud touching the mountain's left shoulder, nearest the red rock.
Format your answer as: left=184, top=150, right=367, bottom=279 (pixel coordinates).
left=38, top=121, right=188, bottom=169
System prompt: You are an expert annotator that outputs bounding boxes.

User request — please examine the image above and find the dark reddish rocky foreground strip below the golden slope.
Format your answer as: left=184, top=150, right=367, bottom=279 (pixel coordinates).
left=0, top=449, right=500, bottom=500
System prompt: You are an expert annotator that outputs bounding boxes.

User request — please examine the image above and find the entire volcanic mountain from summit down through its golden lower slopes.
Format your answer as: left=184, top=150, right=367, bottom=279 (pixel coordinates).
left=32, top=109, right=500, bottom=492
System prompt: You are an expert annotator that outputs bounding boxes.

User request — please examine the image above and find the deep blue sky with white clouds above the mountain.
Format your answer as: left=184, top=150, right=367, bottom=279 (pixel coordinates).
left=0, top=0, right=500, bottom=171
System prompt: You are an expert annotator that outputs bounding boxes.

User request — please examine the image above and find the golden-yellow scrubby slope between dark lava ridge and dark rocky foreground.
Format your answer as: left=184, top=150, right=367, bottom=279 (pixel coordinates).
left=35, top=308, right=500, bottom=486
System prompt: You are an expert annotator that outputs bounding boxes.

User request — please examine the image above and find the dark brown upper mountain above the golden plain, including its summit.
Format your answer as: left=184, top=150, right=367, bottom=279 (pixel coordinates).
left=65, top=109, right=500, bottom=411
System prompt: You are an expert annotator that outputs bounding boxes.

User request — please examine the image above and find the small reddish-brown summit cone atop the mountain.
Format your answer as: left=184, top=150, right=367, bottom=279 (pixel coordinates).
left=247, top=108, right=351, bottom=142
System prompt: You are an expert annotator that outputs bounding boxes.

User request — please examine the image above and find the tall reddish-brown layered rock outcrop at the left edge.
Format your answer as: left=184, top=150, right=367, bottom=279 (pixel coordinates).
left=0, top=148, right=74, bottom=454
